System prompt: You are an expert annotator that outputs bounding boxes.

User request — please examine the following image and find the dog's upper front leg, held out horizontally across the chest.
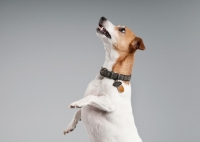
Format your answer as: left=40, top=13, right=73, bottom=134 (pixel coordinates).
left=69, top=93, right=114, bottom=112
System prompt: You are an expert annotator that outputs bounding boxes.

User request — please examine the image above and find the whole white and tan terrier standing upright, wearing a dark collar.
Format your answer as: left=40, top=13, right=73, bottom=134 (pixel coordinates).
left=64, top=17, right=145, bottom=142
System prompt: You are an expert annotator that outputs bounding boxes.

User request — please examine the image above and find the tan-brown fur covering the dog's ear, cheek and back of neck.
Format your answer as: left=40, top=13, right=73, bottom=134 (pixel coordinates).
left=112, top=27, right=145, bottom=84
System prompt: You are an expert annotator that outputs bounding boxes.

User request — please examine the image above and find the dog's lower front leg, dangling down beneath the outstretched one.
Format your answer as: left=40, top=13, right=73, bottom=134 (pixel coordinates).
left=64, top=110, right=81, bottom=135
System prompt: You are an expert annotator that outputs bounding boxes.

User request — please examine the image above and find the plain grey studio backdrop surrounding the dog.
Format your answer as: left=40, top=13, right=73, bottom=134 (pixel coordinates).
left=0, top=0, right=200, bottom=142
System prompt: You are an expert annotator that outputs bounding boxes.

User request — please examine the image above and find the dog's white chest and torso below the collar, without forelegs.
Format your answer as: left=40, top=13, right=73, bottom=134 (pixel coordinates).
left=82, top=79, right=141, bottom=142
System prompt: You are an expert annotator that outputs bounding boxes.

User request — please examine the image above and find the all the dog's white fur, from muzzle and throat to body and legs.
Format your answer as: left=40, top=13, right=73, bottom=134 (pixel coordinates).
left=64, top=21, right=142, bottom=142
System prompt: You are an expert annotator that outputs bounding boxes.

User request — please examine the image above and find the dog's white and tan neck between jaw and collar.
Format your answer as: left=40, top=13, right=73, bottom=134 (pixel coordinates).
left=103, top=44, right=135, bottom=80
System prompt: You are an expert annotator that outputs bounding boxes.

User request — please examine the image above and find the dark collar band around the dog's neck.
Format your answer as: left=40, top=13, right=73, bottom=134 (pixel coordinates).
left=100, top=67, right=131, bottom=81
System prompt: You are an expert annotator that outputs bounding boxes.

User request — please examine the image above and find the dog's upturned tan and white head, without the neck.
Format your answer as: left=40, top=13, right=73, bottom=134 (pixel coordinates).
left=96, top=17, right=145, bottom=54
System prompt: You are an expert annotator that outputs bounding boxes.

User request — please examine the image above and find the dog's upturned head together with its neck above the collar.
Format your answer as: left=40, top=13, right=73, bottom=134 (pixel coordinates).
left=96, top=17, right=145, bottom=75
